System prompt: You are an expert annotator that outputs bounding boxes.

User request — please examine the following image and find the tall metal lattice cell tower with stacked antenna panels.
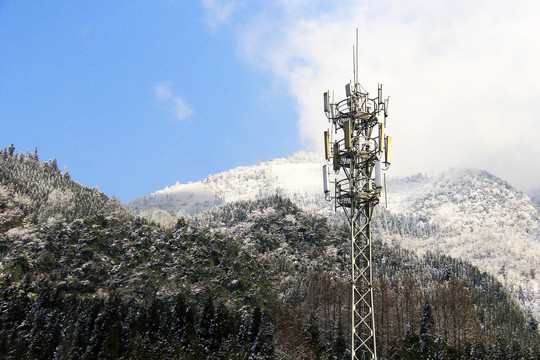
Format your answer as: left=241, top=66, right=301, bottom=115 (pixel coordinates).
left=323, top=31, right=392, bottom=360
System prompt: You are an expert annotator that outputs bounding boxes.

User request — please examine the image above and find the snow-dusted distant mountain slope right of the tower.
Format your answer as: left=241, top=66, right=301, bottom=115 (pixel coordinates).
left=386, top=169, right=540, bottom=318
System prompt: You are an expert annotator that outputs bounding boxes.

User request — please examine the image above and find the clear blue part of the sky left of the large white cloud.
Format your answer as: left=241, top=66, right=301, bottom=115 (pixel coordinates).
left=0, top=1, right=301, bottom=201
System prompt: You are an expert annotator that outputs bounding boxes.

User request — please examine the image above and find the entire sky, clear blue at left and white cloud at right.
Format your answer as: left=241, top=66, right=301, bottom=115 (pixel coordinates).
left=0, top=0, right=540, bottom=201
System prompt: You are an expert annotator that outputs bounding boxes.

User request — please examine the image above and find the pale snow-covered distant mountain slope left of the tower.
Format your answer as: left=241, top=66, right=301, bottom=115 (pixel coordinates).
left=126, top=151, right=330, bottom=215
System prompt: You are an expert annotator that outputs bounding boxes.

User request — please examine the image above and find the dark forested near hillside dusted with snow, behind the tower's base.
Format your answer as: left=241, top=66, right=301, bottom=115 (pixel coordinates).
left=0, top=145, right=540, bottom=359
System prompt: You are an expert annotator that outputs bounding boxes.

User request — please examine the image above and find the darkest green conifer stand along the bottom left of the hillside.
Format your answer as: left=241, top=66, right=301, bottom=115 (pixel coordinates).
left=0, top=283, right=275, bottom=360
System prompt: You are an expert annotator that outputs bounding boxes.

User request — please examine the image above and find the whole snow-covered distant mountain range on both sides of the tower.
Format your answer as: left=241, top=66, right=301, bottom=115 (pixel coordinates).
left=127, top=152, right=540, bottom=319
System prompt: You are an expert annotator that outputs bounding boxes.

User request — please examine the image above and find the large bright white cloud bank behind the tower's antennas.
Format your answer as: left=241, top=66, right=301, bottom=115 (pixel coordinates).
left=234, top=0, right=540, bottom=189
